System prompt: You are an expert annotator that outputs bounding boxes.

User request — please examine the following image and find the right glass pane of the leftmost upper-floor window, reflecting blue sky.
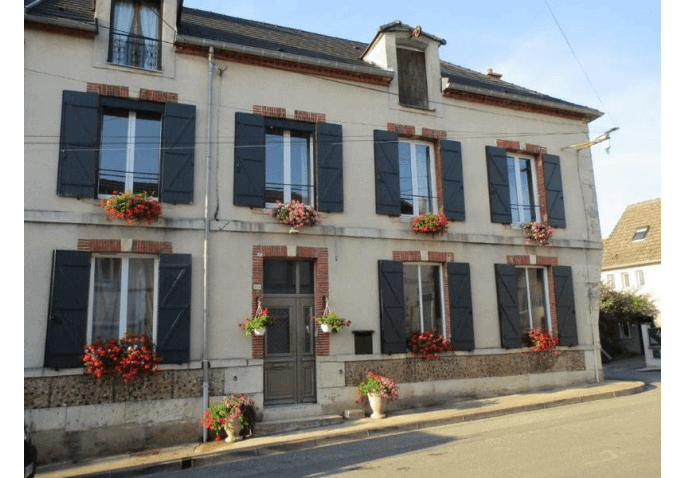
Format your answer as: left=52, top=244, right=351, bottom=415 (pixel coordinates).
left=133, top=113, right=162, bottom=196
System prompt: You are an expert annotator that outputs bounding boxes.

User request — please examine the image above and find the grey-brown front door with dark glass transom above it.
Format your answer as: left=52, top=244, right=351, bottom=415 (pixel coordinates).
left=263, top=260, right=317, bottom=405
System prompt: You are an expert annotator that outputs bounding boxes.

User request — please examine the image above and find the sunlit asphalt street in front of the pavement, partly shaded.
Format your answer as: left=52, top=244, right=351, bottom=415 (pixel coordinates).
left=147, top=373, right=661, bottom=478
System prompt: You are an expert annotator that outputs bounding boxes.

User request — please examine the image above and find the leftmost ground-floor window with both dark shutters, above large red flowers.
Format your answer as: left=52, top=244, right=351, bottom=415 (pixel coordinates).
left=44, top=251, right=191, bottom=368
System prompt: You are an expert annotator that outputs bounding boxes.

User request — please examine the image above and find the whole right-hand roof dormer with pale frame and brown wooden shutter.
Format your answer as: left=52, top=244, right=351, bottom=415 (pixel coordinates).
left=361, top=21, right=446, bottom=111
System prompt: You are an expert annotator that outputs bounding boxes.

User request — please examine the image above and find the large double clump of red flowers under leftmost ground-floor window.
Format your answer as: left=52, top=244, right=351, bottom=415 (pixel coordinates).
left=81, top=332, right=162, bottom=383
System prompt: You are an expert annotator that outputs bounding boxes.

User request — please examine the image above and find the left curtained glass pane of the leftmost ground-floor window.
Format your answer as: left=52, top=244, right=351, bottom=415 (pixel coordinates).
left=91, top=257, right=121, bottom=341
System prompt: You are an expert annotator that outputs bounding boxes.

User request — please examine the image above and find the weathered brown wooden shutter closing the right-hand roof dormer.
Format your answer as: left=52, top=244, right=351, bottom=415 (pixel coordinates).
left=396, top=47, right=429, bottom=109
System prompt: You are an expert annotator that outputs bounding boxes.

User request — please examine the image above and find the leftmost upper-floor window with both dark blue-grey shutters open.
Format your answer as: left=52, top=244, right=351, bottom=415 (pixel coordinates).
left=57, top=91, right=195, bottom=204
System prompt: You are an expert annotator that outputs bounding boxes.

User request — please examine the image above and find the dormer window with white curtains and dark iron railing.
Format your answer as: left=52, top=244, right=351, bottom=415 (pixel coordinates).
left=108, top=0, right=161, bottom=70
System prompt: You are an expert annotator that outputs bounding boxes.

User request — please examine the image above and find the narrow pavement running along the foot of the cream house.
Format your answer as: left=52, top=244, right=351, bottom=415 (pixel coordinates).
left=36, top=357, right=660, bottom=478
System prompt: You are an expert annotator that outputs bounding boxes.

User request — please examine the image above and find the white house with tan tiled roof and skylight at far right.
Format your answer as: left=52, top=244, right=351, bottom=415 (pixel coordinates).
left=601, top=198, right=662, bottom=354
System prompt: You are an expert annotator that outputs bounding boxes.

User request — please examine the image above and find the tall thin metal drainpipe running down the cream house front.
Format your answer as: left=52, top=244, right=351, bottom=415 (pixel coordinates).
left=202, top=46, right=214, bottom=443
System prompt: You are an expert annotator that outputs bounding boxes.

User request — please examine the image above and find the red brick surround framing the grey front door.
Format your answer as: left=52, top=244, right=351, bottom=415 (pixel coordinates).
left=252, top=246, right=330, bottom=358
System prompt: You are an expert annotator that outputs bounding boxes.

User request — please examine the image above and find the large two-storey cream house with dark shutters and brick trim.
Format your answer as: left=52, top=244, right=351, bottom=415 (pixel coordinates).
left=24, top=0, right=602, bottom=462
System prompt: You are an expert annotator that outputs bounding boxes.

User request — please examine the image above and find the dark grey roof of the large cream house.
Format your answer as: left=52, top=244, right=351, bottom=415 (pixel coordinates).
left=24, top=0, right=602, bottom=120
